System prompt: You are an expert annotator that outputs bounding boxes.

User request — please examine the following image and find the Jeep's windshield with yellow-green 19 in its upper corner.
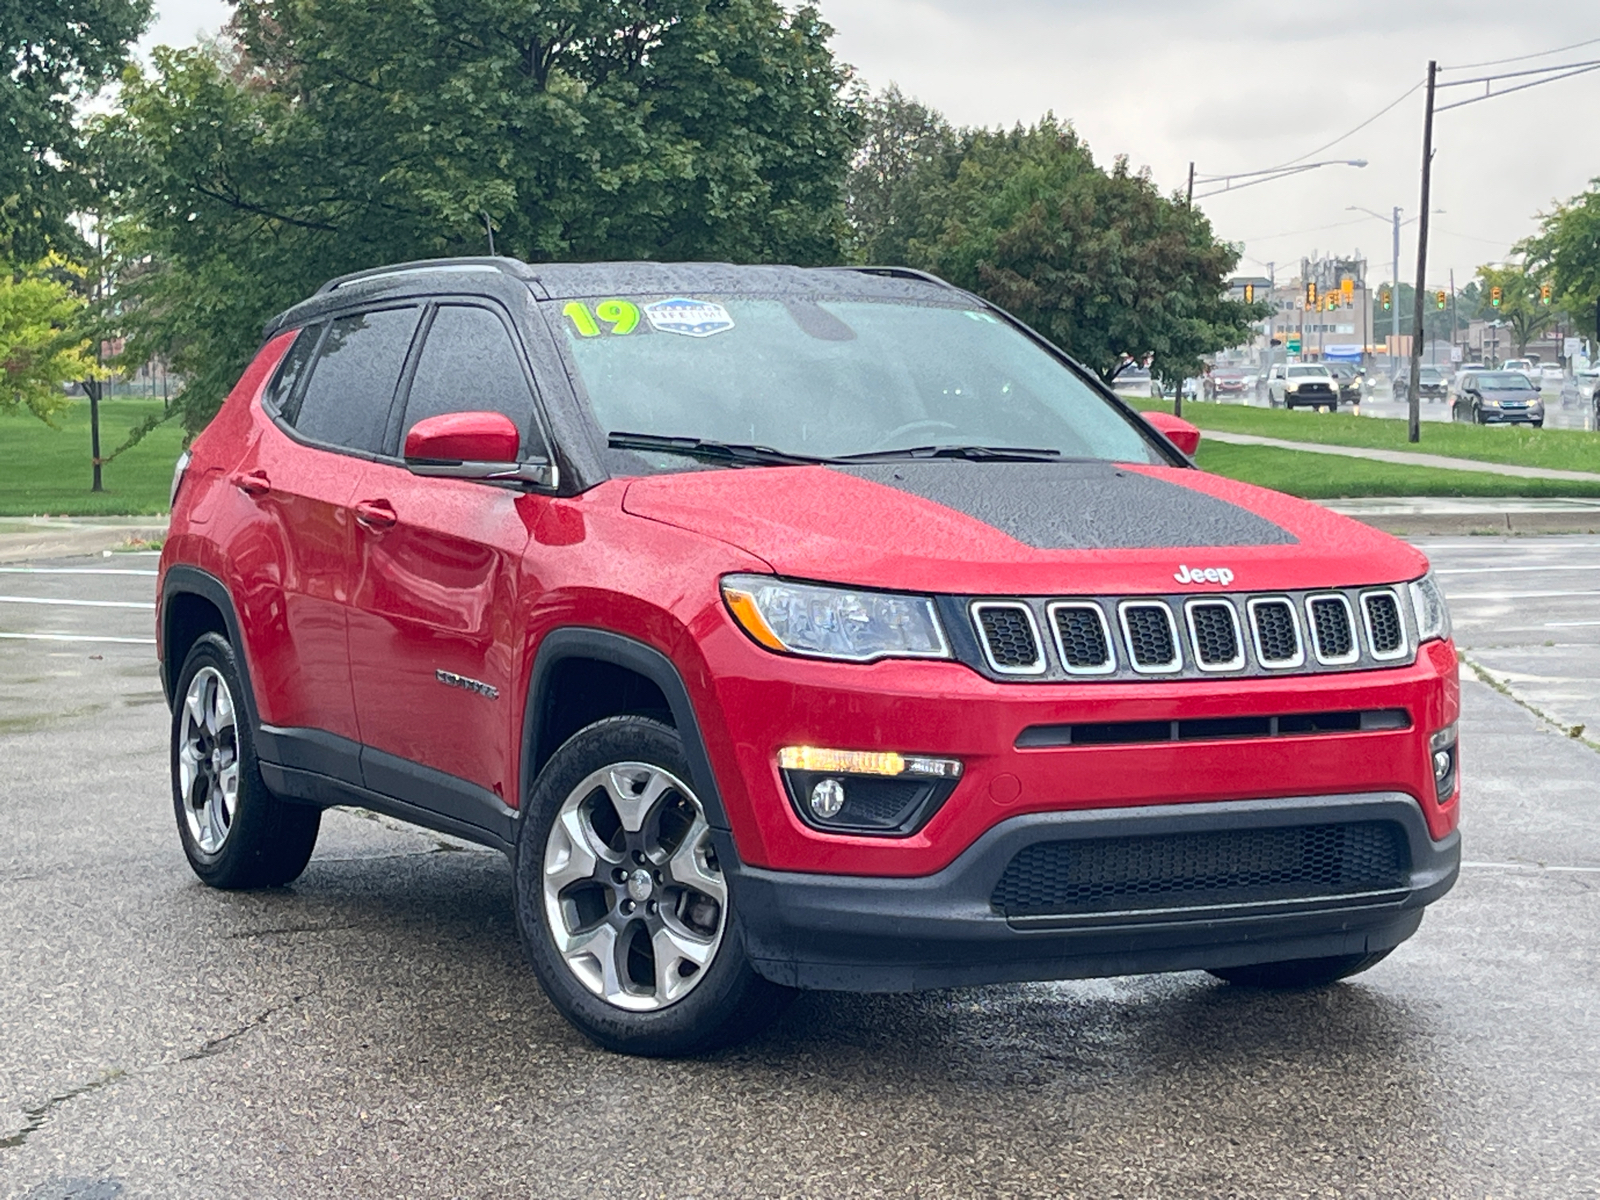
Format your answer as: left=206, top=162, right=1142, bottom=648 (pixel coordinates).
left=552, top=296, right=1166, bottom=470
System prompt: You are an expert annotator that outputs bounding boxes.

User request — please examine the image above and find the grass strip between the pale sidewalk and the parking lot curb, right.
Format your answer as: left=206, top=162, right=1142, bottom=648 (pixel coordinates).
left=1184, top=438, right=1600, bottom=499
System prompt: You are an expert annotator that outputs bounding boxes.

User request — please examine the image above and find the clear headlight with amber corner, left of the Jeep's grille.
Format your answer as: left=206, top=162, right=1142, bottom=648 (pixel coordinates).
left=722, top=574, right=950, bottom=662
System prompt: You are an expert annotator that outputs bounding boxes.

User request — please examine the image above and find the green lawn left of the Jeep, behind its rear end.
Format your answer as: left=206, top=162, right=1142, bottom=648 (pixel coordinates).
left=0, top=398, right=184, bottom=517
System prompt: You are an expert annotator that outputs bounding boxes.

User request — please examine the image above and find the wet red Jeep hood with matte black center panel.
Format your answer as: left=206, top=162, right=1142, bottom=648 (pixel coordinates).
left=622, top=459, right=1427, bottom=595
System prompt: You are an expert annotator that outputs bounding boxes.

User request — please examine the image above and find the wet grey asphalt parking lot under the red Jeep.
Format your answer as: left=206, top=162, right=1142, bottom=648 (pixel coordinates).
left=0, top=547, right=1600, bottom=1200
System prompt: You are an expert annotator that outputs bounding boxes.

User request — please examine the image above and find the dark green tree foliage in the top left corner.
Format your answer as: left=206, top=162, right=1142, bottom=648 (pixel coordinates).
left=0, top=0, right=150, bottom=262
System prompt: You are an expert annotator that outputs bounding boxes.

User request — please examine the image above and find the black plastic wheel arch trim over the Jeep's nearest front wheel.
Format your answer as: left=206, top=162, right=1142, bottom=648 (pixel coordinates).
left=520, top=627, right=731, bottom=853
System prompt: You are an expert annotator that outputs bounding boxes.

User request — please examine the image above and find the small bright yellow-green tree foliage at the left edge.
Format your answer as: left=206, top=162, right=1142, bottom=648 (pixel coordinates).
left=0, top=259, right=101, bottom=424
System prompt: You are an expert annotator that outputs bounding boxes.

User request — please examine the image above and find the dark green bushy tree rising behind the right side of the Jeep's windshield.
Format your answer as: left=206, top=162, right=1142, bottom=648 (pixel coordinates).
left=850, top=104, right=1267, bottom=381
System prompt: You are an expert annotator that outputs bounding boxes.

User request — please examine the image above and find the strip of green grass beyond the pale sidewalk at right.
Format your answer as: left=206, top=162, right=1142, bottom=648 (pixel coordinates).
left=1138, top=400, right=1600, bottom=473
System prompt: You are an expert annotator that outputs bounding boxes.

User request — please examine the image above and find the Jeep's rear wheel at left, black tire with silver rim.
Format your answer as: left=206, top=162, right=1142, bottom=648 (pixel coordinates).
left=171, top=634, right=322, bottom=891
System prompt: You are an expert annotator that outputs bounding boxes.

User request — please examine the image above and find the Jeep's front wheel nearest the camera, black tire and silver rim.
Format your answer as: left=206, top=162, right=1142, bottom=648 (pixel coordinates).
left=514, top=717, right=794, bottom=1058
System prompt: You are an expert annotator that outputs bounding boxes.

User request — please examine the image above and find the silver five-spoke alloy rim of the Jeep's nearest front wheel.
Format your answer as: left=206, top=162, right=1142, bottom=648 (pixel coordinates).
left=542, top=762, right=728, bottom=1013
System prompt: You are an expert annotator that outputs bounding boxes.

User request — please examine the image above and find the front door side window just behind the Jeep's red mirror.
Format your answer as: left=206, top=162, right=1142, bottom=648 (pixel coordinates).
left=400, top=304, right=547, bottom=458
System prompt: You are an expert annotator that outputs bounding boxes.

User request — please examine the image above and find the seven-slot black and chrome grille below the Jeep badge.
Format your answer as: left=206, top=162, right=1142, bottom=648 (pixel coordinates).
left=941, top=587, right=1416, bottom=682
